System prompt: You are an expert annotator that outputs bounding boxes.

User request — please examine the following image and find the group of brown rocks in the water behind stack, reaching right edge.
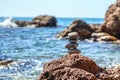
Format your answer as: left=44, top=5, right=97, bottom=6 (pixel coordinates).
left=57, top=0, right=120, bottom=43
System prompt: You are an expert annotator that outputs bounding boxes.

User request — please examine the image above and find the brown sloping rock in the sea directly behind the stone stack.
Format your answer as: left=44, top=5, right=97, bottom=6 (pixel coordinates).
left=57, top=20, right=92, bottom=39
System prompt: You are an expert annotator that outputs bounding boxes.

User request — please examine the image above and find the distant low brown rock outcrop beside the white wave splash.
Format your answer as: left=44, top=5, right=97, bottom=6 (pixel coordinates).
left=15, top=15, right=57, bottom=27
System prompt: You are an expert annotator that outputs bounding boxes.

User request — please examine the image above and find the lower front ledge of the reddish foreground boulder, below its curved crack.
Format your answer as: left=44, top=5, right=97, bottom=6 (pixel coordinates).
left=38, top=67, right=97, bottom=80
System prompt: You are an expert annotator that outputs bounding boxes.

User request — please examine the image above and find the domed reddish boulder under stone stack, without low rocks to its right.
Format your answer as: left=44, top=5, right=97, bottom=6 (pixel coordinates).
left=38, top=54, right=99, bottom=80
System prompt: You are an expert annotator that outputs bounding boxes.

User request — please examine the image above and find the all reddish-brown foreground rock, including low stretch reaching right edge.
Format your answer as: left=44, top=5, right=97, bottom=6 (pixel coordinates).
left=38, top=54, right=120, bottom=80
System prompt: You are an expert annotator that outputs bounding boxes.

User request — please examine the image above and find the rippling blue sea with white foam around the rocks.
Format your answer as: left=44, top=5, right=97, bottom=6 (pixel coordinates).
left=0, top=17, right=120, bottom=80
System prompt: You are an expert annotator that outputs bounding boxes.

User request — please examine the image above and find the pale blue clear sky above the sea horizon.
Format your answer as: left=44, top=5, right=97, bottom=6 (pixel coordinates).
left=0, top=0, right=116, bottom=18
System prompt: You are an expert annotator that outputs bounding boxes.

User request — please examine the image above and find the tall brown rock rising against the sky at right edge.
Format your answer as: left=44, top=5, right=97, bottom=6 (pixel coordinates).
left=100, top=0, right=120, bottom=39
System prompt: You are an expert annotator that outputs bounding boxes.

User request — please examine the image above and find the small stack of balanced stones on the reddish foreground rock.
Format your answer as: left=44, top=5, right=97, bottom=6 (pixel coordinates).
left=65, top=32, right=81, bottom=54
